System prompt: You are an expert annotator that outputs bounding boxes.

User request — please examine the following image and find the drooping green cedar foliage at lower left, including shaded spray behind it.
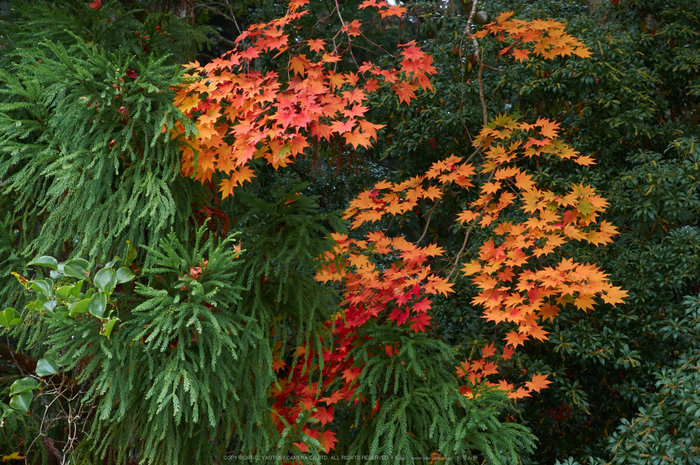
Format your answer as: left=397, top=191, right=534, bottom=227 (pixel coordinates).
left=3, top=182, right=348, bottom=463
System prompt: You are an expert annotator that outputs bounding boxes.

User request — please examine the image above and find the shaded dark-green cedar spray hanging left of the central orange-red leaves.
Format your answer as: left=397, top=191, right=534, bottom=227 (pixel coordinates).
left=230, top=181, right=339, bottom=362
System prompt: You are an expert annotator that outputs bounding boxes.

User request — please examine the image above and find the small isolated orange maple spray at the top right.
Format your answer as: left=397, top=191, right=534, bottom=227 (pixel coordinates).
left=474, top=12, right=591, bottom=62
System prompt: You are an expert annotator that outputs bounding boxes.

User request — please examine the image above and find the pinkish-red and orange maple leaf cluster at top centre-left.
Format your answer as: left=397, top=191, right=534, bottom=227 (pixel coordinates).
left=174, top=0, right=436, bottom=198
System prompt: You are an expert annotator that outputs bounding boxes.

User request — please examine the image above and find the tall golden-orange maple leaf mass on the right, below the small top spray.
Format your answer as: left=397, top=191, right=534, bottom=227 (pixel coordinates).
left=457, top=116, right=627, bottom=398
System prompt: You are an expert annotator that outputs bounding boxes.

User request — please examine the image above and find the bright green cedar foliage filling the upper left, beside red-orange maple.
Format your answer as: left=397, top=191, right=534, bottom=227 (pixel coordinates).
left=0, top=1, right=208, bottom=271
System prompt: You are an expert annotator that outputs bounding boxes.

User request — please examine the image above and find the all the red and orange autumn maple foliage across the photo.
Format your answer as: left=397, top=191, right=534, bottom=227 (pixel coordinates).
left=174, top=0, right=626, bottom=452
